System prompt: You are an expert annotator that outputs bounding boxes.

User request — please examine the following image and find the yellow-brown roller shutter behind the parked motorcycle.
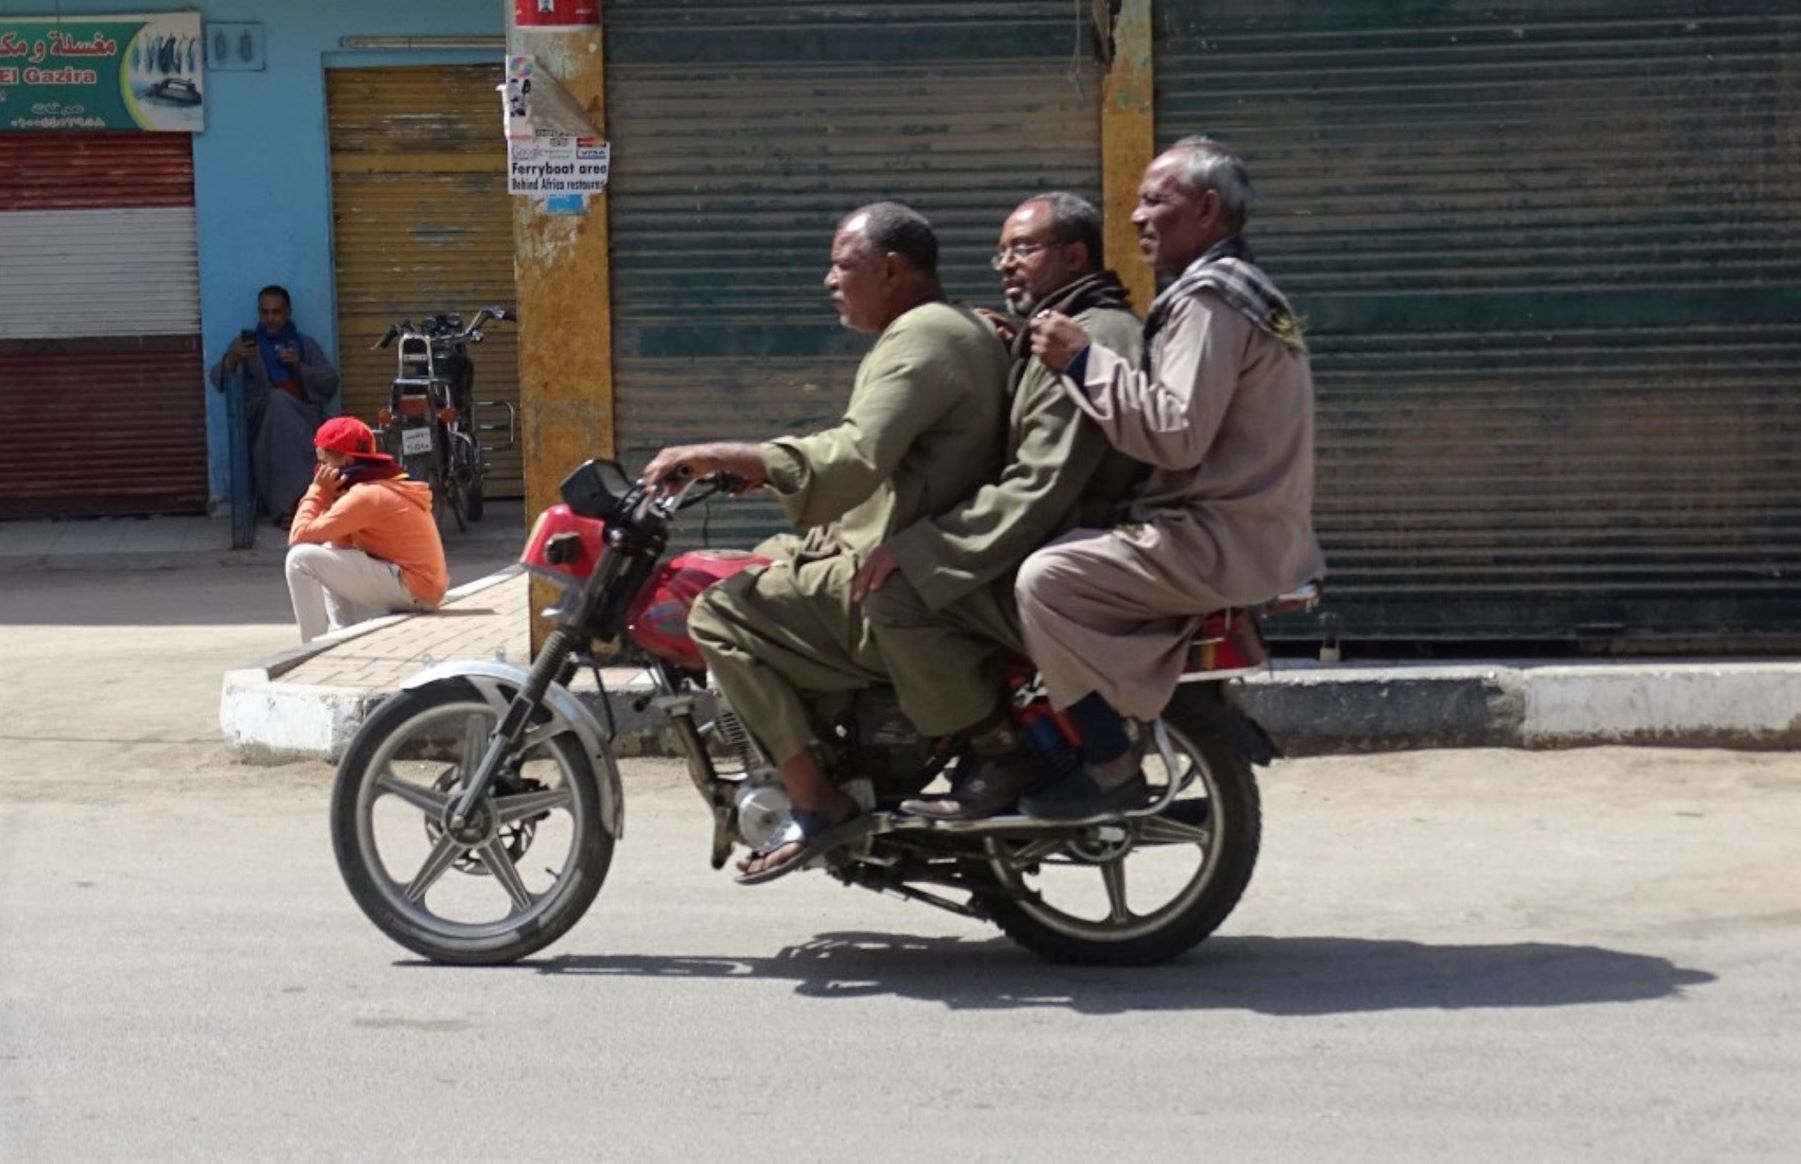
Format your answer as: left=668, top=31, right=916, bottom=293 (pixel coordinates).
left=326, top=65, right=524, bottom=497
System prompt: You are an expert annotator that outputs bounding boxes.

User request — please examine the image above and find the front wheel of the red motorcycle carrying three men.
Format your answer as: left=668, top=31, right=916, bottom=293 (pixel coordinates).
left=331, top=679, right=612, bottom=966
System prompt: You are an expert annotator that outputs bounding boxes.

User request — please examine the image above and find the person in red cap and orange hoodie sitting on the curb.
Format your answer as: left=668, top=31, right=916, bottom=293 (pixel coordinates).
left=288, top=416, right=450, bottom=643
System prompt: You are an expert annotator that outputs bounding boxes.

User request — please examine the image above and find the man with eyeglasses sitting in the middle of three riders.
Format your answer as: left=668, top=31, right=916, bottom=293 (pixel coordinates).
left=854, top=191, right=1140, bottom=820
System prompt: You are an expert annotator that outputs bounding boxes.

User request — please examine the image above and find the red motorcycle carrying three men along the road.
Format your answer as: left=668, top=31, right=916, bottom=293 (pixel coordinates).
left=331, top=461, right=1318, bottom=966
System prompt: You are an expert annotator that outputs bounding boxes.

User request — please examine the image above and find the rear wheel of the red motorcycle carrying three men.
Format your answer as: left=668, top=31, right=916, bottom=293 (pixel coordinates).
left=987, top=696, right=1261, bottom=966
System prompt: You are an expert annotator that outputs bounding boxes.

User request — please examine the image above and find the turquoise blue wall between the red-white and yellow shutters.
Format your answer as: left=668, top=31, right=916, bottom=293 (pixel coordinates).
left=0, top=0, right=506, bottom=503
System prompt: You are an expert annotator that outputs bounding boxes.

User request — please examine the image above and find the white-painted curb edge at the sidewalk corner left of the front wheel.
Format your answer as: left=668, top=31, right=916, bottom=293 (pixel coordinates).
left=220, top=566, right=520, bottom=764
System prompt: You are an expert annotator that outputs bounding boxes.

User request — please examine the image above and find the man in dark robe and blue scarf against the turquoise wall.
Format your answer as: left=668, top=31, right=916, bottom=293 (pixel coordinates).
left=207, top=286, right=339, bottom=530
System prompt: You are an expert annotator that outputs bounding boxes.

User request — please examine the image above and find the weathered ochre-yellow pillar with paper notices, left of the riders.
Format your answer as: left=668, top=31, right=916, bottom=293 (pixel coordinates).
left=495, top=0, right=614, bottom=650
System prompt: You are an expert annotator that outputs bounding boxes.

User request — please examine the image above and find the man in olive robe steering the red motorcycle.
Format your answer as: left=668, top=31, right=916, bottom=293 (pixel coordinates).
left=645, top=202, right=1007, bottom=885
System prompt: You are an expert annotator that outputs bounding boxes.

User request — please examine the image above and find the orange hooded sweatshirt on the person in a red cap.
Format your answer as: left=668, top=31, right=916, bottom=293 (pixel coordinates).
left=288, top=477, right=450, bottom=605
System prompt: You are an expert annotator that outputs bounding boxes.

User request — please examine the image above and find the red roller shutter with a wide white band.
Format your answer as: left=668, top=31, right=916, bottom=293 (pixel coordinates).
left=0, top=133, right=207, bottom=517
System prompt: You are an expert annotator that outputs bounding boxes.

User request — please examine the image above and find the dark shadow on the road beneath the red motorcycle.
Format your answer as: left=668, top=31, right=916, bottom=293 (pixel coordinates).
left=522, top=933, right=1715, bottom=1014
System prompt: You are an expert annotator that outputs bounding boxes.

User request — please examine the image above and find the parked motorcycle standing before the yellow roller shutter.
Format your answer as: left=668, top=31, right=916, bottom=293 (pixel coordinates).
left=371, top=306, right=519, bottom=532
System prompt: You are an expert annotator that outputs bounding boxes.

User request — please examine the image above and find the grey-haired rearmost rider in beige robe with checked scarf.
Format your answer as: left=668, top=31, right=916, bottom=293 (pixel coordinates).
left=1018, top=137, right=1326, bottom=820
